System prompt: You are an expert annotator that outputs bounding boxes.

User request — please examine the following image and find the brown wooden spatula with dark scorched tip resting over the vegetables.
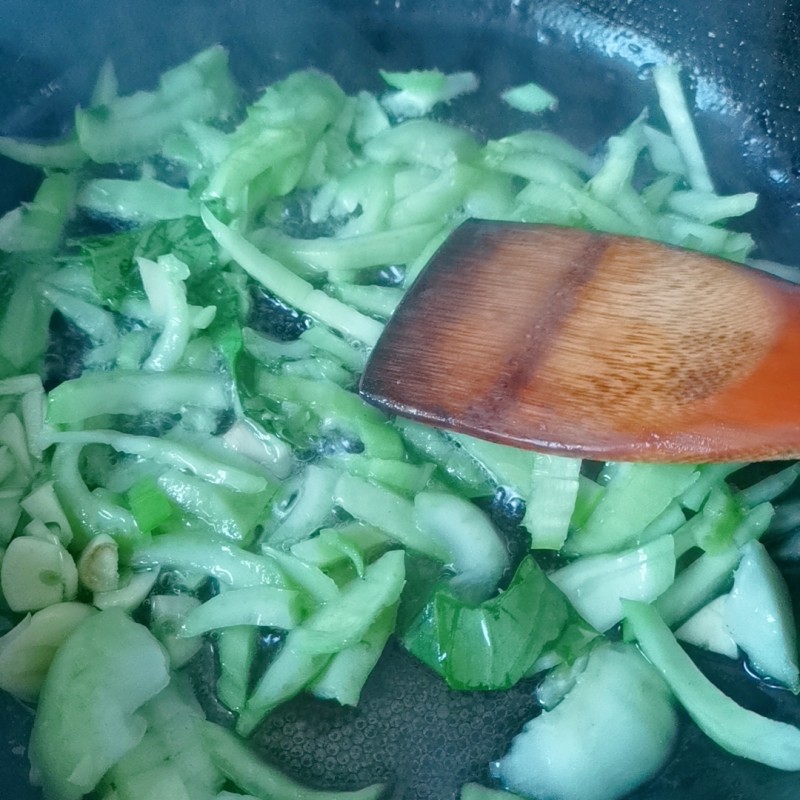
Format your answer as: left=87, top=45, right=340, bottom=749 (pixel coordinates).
left=360, top=220, right=800, bottom=462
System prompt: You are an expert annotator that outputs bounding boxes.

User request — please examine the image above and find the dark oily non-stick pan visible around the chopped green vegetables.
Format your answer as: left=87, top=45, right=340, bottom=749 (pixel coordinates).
left=0, top=0, right=800, bottom=800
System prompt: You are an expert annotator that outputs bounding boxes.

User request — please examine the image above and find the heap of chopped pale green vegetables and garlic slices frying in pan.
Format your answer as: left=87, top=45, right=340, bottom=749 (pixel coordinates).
left=0, top=47, right=800, bottom=800
